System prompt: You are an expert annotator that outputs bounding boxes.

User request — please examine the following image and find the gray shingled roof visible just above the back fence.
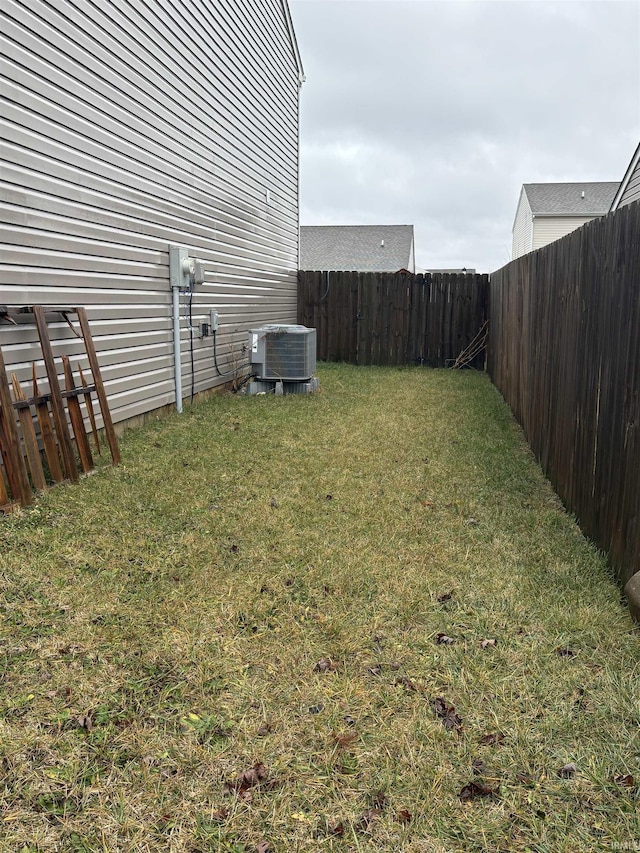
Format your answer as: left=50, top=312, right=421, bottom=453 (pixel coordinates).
left=300, top=225, right=415, bottom=272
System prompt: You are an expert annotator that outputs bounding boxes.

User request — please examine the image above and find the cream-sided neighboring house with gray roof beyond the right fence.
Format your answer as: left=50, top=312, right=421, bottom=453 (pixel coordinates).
left=511, top=181, right=619, bottom=260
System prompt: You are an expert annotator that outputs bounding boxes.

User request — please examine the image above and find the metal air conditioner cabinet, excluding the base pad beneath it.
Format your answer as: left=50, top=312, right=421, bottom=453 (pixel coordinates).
left=249, top=324, right=316, bottom=382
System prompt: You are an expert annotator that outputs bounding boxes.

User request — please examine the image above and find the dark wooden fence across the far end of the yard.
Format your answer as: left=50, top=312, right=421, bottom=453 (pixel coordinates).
left=298, top=271, right=489, bottom=369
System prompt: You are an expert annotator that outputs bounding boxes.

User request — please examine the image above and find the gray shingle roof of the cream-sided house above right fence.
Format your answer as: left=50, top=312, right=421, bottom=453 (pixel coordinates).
left=524, top=181, right=620, bottom=216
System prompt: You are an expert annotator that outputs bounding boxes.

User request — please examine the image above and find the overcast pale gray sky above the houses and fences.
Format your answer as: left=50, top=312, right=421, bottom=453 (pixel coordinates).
left=290, top=0, right=640, bottom=272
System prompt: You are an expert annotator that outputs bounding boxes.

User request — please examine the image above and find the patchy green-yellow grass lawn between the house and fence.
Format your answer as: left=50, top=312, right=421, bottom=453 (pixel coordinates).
left=0, top=365, right=640, bottom=853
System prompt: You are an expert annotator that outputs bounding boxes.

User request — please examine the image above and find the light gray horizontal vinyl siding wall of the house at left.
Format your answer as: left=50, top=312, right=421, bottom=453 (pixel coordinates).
left=0, top=0, right=300, bottom=421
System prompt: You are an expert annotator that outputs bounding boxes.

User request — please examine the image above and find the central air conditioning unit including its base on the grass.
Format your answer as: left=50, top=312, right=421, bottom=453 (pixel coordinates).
left=248, top=324, right=318, bottom=394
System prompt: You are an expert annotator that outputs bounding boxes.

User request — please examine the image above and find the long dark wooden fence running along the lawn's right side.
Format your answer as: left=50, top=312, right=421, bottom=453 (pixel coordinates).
left=488, top=202, right=640, bottom=583
